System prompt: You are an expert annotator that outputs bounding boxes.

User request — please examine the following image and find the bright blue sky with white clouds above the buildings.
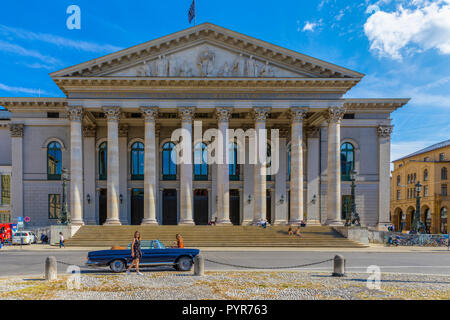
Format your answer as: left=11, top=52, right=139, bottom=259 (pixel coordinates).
left=0, top=0, right=450, bottom=160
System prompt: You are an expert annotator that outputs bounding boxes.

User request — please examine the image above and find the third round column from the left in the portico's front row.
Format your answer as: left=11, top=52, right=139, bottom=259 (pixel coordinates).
left=141, top=107, right=158, bottom=224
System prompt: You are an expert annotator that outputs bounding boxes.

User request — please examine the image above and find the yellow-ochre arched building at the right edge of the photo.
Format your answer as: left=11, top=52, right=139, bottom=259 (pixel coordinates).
left=391, top=140, right=450, bottom=233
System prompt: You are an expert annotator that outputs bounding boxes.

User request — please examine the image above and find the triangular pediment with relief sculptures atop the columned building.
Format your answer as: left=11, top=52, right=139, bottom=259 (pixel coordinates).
left=51, top=23, right=363, bottom=78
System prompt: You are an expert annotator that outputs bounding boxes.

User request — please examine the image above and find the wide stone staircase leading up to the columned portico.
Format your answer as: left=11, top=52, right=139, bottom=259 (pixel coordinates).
left=66, top=226, right=366, bottom=248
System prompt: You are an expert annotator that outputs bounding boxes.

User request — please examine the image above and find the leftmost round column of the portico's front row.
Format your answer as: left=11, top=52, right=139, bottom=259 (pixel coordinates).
left=67, top=106, right=84, bottom=225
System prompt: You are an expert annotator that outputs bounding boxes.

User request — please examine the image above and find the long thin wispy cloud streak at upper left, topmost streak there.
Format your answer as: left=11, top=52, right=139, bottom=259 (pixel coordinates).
left=0, top=24, right=122, bottom=52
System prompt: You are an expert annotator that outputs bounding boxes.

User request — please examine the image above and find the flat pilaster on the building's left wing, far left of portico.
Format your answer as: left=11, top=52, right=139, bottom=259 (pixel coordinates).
left=9, top=123, right=24, bottom=222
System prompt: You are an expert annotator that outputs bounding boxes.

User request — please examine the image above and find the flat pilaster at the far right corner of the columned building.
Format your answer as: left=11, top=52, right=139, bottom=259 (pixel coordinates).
left=377, top=125, right=393, bottom=230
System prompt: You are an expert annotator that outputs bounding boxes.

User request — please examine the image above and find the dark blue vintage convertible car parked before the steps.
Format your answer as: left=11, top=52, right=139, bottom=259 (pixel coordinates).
left=86, top=240, right=200, bottom=272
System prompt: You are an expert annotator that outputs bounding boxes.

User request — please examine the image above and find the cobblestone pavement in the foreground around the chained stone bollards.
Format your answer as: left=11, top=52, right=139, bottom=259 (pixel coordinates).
left=0, top=271, right=450, bottom=300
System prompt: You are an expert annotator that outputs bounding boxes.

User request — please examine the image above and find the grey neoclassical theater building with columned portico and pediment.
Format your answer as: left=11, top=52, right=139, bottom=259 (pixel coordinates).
left=0, top=23, right=408, bottom=228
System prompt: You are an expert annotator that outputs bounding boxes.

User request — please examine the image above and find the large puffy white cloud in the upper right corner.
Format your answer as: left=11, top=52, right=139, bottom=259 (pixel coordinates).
left=364, top=0, right=450, bottom=60
